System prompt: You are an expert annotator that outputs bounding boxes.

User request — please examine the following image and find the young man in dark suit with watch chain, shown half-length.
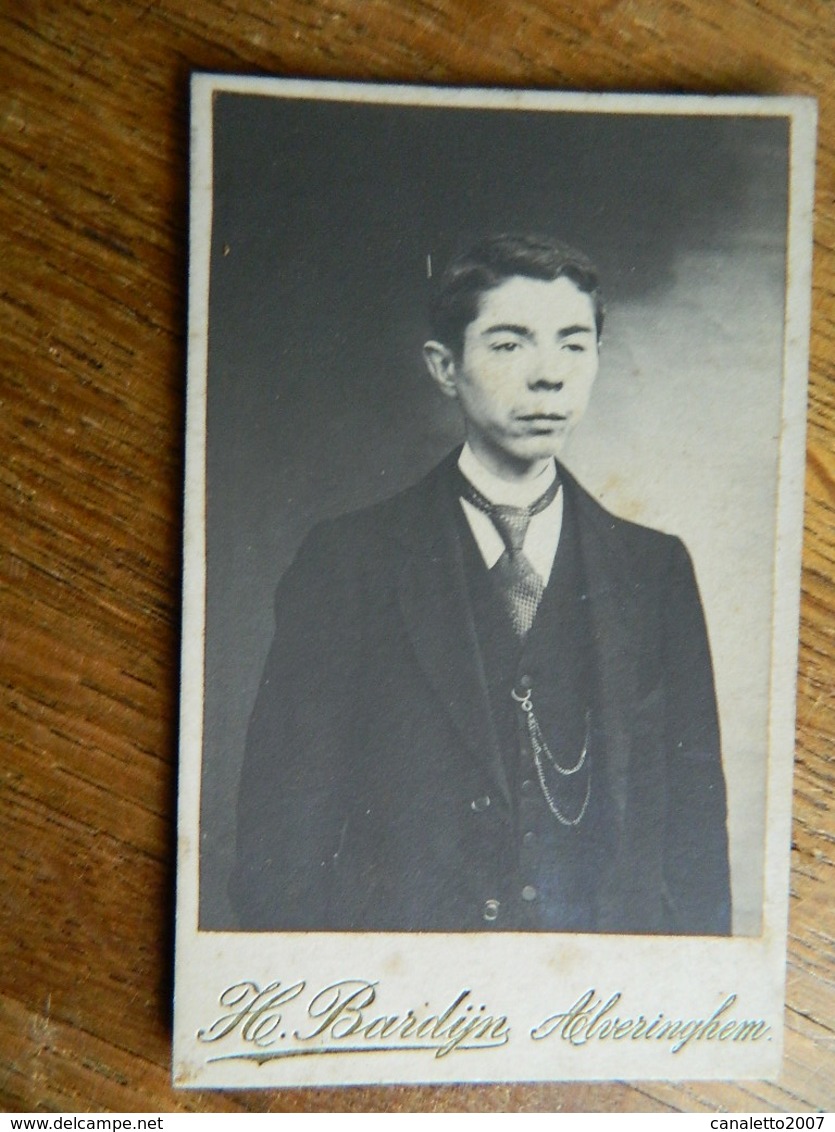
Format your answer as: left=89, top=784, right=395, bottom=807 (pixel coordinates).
left=230, top=234, right=731, bottom=935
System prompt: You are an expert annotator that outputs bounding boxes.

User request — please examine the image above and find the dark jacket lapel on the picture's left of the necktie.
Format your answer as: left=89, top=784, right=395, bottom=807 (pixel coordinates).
left=398, top=453, right=510, bottom=804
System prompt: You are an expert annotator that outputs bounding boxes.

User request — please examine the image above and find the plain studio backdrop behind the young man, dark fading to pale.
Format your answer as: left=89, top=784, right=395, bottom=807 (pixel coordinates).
left=200, top=94, right=787, bottom=934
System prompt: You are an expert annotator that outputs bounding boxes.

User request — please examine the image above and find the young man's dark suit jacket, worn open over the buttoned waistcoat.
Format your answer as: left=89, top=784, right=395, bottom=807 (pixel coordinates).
left=230, top=456, right=730, bottom=934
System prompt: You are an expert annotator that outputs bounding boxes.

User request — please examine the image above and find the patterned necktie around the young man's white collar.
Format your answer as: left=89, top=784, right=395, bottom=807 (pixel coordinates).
left=460, top=473, right=560, bottom=637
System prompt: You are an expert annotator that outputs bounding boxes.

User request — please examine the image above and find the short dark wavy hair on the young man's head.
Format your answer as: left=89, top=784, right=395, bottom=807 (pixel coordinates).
left=429, top=234, right=603, bottom=353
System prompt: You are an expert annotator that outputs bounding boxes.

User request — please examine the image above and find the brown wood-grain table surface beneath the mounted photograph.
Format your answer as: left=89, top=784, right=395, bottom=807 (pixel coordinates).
left=0, top=0, right=835, bottom=1112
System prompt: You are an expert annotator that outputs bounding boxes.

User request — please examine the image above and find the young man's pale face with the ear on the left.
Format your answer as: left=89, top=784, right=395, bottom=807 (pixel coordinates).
left=427, top=275, right=599, bottom=479
